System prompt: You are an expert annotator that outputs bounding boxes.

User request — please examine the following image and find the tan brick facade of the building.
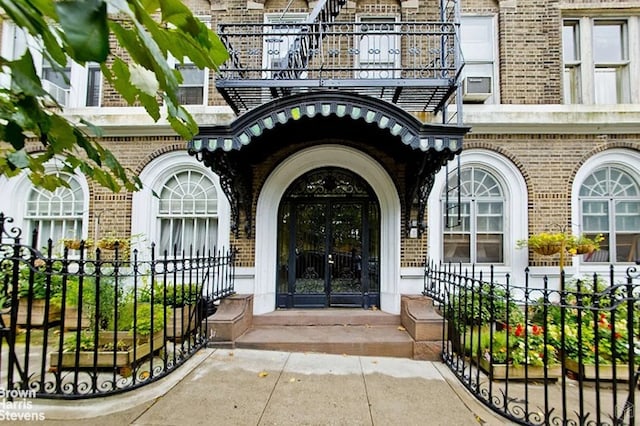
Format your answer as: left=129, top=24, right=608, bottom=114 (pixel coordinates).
left=5, top=0, right=640, bottom=300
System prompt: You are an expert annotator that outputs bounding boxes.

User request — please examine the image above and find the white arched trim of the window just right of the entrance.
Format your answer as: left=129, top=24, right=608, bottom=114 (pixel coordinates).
left=427, top=149, right=529, bottom=282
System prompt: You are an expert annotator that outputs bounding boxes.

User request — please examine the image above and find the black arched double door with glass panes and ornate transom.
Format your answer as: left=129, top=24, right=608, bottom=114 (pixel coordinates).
left=276, top=167, right=380, bottom=308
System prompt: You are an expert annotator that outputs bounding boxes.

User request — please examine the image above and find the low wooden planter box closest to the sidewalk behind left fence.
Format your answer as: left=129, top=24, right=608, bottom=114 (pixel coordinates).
left=49, top=331, right=164, bottom=376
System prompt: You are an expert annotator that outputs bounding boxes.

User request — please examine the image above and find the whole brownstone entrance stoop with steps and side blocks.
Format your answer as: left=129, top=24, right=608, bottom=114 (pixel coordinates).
left=207, top=296, right=442, bottom=360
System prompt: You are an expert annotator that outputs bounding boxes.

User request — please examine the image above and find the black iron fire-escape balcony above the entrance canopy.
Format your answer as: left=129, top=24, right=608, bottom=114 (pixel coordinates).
left=216, top=18, right=462, bottom=114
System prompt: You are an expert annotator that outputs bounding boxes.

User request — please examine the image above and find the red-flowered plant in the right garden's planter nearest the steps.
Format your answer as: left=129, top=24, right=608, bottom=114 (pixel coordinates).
left=481, top=323, right=559, bottom=367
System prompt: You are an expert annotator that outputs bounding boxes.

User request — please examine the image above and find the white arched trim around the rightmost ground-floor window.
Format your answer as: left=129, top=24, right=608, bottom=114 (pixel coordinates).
left=571, top=149, right=640, bottom=273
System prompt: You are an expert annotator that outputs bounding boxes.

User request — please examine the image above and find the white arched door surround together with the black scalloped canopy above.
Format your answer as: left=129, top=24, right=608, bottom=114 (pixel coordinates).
left=189, top=90, right=468, bottom=314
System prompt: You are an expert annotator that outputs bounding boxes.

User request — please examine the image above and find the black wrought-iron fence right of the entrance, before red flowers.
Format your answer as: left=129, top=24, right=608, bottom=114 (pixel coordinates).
left=424, top=263, right=640, bottom=425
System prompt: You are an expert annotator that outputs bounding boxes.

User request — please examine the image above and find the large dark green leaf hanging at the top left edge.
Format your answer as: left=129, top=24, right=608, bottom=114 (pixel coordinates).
left=55, top=0, right=109, bottom=62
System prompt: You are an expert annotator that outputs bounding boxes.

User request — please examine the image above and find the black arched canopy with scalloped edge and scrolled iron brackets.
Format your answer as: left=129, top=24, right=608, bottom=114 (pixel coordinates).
left=188, top=92, right=469, bottom=236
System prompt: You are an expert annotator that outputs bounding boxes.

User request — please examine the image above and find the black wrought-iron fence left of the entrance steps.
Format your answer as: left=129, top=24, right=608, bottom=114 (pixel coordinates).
left=0, top=213, right=235, bottom=398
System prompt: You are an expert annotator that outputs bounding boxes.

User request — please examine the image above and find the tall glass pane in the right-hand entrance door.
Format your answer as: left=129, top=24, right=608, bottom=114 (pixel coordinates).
left=329, top=203, right=363, bottom=293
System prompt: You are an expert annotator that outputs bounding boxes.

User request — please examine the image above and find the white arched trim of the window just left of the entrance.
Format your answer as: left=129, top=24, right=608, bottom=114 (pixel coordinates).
left=131, top=151, right=231, bottom=259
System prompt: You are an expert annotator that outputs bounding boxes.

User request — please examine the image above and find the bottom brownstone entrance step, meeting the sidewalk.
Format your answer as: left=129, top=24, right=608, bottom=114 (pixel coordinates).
left=235, top=324, right=414, bottom=358
